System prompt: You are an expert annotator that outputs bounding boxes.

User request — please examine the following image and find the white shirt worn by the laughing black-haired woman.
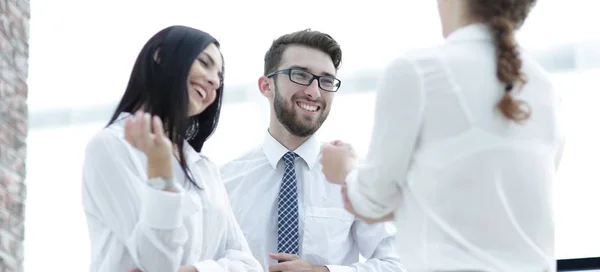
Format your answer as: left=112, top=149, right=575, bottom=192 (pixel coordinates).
left=82, top=114, right=263, bottom=272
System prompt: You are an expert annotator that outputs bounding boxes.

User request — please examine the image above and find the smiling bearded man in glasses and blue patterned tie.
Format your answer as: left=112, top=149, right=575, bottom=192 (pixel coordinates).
left=221, top=30, right=402, bottom=272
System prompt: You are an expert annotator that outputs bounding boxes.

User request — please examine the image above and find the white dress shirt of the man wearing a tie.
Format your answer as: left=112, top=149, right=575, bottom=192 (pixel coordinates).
left=221, top=132, right=401, bottom=272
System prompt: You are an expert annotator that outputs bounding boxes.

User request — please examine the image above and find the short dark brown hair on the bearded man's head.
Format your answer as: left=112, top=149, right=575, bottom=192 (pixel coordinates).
left=264, top=29, right=342, bottom=75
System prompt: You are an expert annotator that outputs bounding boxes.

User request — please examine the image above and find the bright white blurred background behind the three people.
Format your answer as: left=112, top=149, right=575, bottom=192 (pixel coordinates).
left=0, top=0, right=600, bottom=271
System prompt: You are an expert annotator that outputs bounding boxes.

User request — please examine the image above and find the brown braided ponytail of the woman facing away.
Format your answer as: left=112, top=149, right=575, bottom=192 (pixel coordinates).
left=468, top=0, right=536, bottom=123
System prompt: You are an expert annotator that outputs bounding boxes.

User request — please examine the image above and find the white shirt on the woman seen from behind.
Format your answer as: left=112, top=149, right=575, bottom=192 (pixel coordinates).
left=347, top=24, right=563, bottom=272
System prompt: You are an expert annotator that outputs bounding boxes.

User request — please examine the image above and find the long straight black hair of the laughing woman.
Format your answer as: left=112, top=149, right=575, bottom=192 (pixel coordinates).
left=107, top=25, right=224, bottom=187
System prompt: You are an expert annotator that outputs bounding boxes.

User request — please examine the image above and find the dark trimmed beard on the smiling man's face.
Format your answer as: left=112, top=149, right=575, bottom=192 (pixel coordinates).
left=273, top=87, right=329, bottom=137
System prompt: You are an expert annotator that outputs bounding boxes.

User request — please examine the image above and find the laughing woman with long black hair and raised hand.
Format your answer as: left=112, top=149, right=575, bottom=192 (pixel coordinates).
left=82, top=26, right=262, bottom=272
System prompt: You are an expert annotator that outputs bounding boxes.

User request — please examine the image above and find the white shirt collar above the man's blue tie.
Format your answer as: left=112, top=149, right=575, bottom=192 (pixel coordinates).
left=262, top=131, right=321, bottom=170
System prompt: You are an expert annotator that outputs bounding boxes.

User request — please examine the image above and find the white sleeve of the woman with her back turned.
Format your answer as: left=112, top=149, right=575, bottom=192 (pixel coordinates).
left=346, top=58, right=425, bottom=218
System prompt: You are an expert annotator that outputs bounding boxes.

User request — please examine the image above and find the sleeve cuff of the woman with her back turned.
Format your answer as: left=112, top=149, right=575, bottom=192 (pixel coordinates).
left=346, top=169, right=391, bottom=218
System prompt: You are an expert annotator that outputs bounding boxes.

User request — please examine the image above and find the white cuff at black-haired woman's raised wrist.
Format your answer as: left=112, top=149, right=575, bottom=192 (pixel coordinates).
left=140, top=184, right=184, bottom=230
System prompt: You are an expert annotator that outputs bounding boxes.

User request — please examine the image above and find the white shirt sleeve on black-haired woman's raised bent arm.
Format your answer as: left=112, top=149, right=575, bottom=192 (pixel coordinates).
left=82, top=129, right=187, bottom=272
